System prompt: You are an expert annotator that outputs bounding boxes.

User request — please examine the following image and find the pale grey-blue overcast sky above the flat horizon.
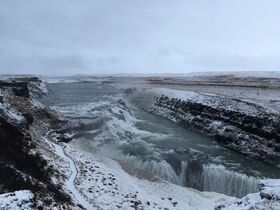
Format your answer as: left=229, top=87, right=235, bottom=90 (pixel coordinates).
left=0, top=0, right=280, bottom=75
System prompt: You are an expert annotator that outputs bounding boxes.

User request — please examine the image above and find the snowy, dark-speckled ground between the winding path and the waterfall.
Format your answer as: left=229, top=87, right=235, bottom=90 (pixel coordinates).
left=66, top=145, right=230, bottom=210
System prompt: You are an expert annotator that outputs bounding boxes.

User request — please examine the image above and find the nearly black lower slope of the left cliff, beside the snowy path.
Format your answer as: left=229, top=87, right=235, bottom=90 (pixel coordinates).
left=0, top=116, right=70, bottom=205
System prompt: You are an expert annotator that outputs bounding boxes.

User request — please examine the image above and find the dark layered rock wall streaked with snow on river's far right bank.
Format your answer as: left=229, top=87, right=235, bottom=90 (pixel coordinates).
left=150, top=96, right=280, bottom=164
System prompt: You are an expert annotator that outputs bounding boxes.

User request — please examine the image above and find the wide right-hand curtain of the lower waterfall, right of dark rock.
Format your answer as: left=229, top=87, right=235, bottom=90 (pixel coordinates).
left=201, top=164, right=259, bottom=197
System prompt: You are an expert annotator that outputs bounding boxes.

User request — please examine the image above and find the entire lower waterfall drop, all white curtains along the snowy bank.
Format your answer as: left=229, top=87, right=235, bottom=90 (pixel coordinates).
left=118, top=156, right=259, bottom=198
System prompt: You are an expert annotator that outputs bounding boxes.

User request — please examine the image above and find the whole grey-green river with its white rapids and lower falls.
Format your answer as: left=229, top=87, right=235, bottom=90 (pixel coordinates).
left=43, top=83, right=280, bottom=197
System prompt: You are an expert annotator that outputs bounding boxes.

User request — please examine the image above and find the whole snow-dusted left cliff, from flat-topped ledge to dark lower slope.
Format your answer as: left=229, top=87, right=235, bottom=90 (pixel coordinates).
left=0, top=78, right=71, bottom=209
